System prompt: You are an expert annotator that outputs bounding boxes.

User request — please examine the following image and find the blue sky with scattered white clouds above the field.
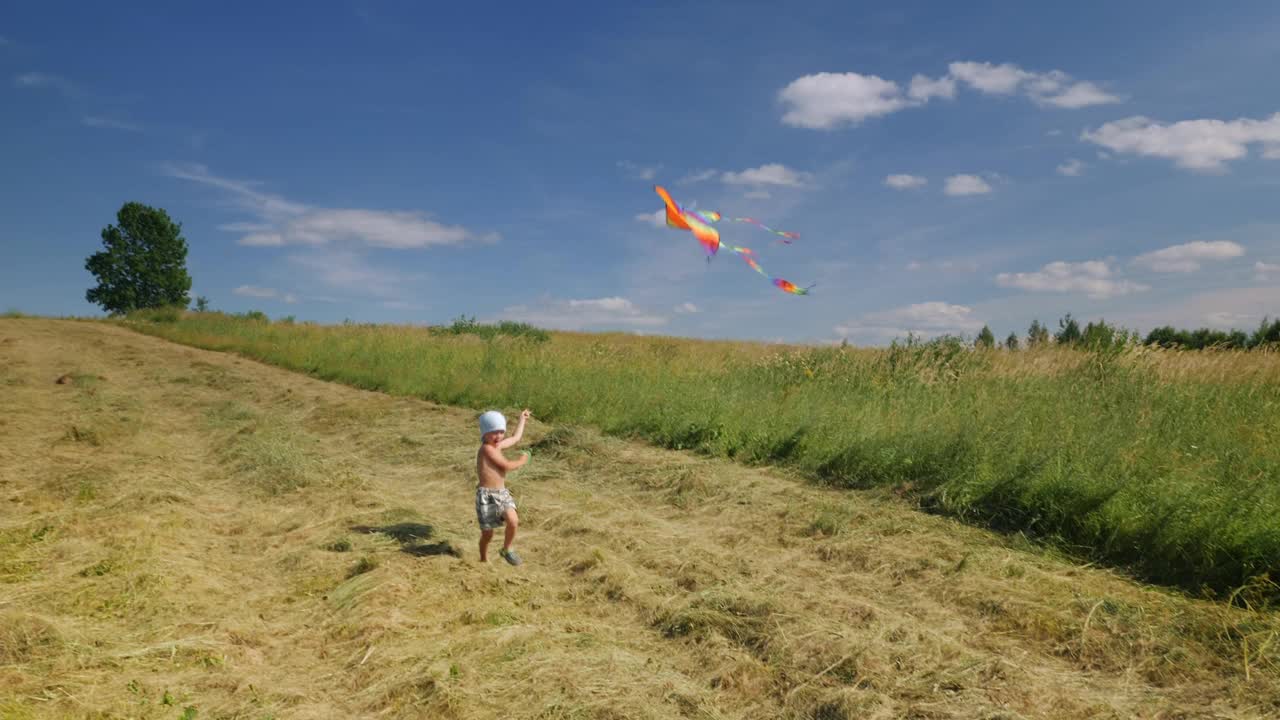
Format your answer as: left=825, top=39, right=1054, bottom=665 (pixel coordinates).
left=0, top=0, right=1280, bottom=345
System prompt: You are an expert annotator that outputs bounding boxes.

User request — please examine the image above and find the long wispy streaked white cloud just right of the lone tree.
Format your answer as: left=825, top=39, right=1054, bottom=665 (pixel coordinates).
left=161, top=165, right=498, bottom=250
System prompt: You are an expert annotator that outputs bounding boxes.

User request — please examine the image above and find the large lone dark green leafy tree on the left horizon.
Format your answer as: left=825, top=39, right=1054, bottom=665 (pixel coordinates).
left=84, top=202, right=191, bottom=314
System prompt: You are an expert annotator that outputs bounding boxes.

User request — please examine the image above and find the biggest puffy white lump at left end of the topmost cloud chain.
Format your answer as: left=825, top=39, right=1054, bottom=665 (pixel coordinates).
left=778, top=73, right=910, bottom=129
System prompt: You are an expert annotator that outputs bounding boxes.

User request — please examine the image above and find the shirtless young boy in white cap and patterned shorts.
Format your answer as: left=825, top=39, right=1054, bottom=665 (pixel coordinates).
left=476, top=410, right=529, bottom=565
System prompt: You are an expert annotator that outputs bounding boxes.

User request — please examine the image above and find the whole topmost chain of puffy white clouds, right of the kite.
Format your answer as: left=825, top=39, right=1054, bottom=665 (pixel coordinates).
left=778, top=61, right=1121, bottom=129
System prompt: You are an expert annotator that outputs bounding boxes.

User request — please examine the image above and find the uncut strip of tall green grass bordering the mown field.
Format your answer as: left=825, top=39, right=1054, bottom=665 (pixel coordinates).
left=122, top=313, right=1280, bottom=593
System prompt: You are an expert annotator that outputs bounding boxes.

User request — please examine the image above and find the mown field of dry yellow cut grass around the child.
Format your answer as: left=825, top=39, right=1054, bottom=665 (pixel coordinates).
left=0, top=319, right=1280, bottom=720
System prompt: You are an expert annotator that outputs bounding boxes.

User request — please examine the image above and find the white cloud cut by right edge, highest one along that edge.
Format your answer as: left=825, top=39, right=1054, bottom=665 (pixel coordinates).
left=1080, top=113, right=1280, bottom=172
